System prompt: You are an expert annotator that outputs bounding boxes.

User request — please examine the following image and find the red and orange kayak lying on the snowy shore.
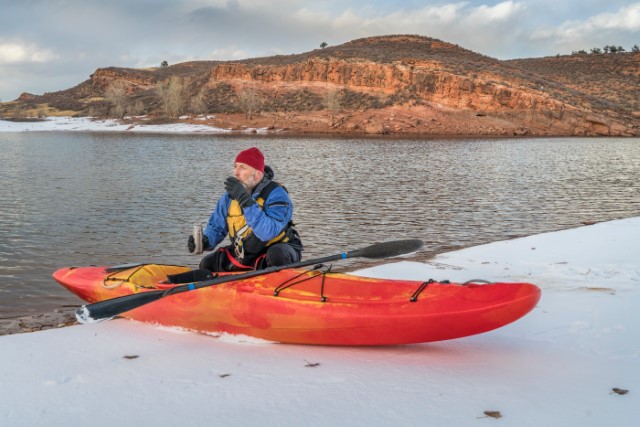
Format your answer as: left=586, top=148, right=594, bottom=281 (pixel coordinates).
left=53, top=264, right=540, bottom=345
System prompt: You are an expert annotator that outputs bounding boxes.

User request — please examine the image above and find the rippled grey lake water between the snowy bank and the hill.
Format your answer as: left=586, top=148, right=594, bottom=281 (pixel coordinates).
left=0, top=132, right=640, bottom=318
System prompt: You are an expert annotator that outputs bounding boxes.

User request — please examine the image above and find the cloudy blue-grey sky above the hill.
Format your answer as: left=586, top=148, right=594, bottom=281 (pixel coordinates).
left=0, top=0, right=640, bottom=102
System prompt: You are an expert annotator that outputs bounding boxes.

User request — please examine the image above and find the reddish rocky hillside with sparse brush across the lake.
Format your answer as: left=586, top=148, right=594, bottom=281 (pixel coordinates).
left=0, top=36, right=640, bottom=136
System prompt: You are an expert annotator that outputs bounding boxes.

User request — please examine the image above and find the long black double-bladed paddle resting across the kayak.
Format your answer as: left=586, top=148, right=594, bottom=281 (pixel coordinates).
left=76, top=239, right=424, bottom=323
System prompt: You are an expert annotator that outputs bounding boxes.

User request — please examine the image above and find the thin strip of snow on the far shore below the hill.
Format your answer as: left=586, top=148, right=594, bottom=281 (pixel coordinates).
left=0, top=117, right=266, bottom=133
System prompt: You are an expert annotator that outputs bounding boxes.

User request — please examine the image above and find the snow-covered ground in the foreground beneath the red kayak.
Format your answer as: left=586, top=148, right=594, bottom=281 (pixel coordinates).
left=0, top=217, right=640, bottom=427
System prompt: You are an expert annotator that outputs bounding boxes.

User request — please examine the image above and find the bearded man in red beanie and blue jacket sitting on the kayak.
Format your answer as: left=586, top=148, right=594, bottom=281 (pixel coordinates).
left=188, top=147, right=302, bottom=272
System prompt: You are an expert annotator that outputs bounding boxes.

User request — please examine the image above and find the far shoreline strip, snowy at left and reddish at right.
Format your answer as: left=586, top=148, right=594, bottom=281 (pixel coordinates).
left=0, top=113, right=635, bottom=140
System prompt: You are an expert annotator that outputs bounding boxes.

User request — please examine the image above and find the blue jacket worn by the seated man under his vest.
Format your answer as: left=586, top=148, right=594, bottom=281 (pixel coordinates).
left=204, top=166, right=293, bottom=249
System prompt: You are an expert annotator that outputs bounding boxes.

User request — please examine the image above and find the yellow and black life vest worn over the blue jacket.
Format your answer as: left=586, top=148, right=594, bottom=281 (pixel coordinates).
left=227, top=181, right=293, bottom=266
